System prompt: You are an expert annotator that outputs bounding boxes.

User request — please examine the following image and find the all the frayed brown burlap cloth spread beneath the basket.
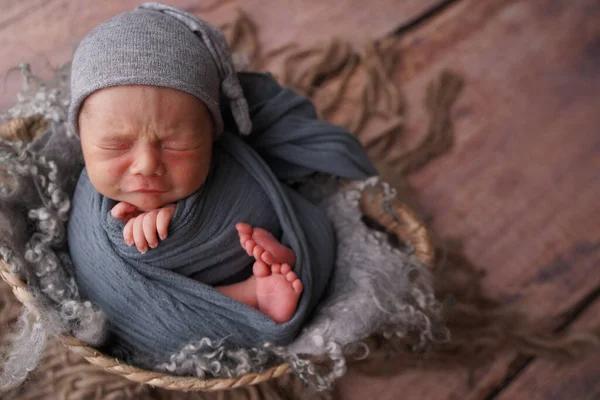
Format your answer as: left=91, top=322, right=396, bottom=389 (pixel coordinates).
left=0, top=6, right=599, bottom=400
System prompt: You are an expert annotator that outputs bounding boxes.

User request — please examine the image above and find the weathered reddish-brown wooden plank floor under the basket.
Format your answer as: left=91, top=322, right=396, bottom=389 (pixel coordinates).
left=0, top=0, right=600, bottom=400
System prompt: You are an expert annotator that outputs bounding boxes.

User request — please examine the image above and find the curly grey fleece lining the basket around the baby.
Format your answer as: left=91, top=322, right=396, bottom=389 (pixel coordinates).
left=0, top=66, right=443, bottom=390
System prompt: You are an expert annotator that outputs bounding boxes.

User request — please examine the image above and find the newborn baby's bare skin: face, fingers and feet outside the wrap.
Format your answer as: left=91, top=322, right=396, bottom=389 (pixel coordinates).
left=79, top=85, right=302, bottom=323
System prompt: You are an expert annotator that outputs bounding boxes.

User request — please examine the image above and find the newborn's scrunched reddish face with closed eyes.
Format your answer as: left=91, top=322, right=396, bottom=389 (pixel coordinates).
left=79, top=85, right=214, bottom=211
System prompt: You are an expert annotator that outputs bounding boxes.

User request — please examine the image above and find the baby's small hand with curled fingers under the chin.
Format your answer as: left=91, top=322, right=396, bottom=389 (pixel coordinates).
left=111, top=202, right=175, bottom=253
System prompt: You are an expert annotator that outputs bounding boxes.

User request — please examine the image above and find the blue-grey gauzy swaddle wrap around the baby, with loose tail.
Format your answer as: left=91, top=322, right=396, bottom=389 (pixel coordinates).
left=68, top=73, right=376, bottom=361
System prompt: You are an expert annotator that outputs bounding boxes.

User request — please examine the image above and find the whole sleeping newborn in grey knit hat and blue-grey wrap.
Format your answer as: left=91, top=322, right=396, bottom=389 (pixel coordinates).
left=68, top=3, right=375, bottom=363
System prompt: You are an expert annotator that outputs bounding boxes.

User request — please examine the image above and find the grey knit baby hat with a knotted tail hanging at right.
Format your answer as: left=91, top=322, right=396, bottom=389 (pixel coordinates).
left=69, top=3, right=252, bottom=135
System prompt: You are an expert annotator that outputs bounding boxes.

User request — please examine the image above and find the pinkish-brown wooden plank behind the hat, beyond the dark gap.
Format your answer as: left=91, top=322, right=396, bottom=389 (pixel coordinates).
left=0, top=0, right=441, bottom=110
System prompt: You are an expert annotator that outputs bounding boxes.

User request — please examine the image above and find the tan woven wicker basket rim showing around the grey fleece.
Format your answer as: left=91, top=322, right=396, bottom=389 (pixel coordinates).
left=0, top=118, right=434, bottom=391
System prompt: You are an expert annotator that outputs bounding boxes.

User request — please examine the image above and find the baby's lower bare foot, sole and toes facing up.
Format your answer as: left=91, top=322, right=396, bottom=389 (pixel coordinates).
left=253, top=260, right=302, bottom=324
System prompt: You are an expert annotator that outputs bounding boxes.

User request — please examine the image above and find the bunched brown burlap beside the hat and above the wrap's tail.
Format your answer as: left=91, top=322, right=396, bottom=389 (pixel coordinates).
left=224, top=11, right=463, bottom=181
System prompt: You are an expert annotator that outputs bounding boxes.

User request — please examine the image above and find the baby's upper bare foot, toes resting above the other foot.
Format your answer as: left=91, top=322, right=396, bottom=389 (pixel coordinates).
left=235, top=222, right=296, bottom=266
